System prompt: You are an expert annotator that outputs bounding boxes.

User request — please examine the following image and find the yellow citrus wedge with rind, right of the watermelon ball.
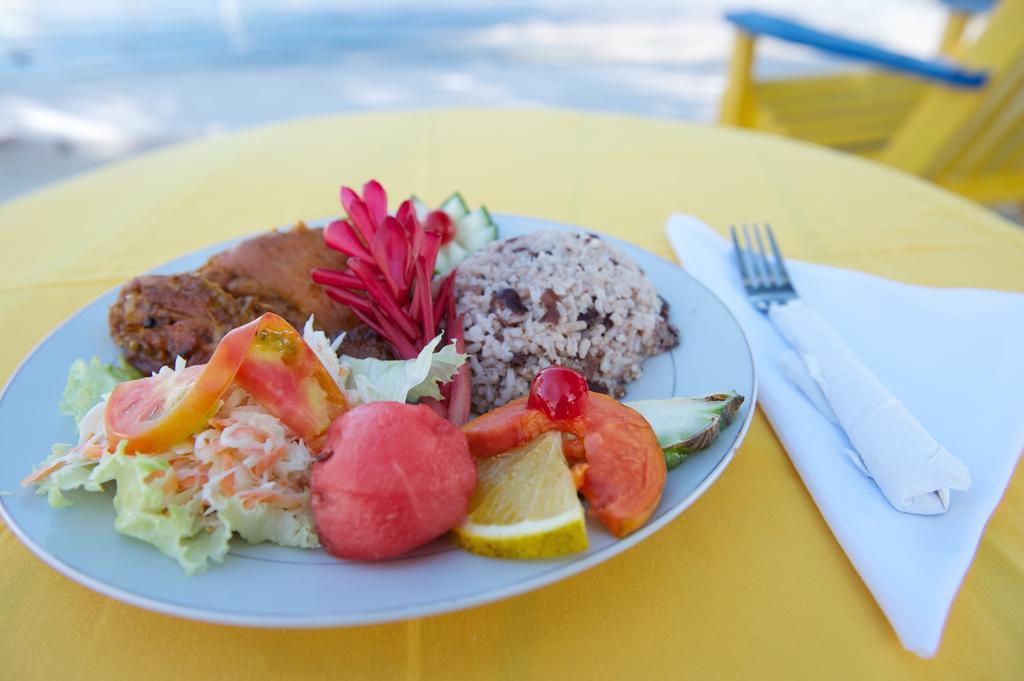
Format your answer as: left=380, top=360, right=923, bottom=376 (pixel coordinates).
left=454, top=432, right=587, bottom=558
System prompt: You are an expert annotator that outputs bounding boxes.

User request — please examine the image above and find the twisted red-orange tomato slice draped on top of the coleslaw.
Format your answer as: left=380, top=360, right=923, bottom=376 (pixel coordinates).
left=104, top=312, right=347, bottom=453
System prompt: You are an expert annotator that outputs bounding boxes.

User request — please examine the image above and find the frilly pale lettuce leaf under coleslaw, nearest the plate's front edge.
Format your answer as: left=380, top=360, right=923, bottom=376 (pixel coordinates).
left=93, top=453, right=231, bottom=574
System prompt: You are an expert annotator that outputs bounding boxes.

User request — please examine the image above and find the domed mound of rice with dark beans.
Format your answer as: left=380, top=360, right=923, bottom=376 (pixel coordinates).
left=456, top=231, right=679, bottom=414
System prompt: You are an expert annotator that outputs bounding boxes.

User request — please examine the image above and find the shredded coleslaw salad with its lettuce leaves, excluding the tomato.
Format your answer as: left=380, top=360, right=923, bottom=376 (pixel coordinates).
left=23, top=317, right=465, bottom=574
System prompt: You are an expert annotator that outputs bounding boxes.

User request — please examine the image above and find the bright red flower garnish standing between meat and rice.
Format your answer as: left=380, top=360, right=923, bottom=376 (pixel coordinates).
left=312, top=180, right=470, bottom=425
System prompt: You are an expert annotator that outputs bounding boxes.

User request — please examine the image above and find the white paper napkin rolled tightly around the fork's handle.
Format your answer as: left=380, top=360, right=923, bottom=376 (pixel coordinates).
left=768, top=300, right=971, bottom=514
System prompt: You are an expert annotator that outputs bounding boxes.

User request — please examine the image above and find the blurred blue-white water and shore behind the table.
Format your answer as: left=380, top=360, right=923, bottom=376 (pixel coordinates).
left=0, top=0, right=945, bottom=199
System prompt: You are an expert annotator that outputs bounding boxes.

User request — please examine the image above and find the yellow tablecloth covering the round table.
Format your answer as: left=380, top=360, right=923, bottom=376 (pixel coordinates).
left=0, top=111, right=1024, bottom=681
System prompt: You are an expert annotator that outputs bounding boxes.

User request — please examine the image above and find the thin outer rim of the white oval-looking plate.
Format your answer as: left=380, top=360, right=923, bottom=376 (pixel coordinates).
left=0, top=213, right=759, bottom=629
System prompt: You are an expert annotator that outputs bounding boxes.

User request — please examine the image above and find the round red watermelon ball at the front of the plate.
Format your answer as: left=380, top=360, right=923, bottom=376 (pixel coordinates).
left=309, top=402, right=476, bottom=560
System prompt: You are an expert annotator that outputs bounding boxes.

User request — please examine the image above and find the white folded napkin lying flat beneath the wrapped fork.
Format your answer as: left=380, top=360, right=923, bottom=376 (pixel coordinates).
left=666, top=215, right=1024, bottom=657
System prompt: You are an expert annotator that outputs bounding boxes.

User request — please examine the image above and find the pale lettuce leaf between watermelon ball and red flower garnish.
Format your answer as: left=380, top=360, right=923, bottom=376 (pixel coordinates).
left=341, top=335, right=466, bottom=405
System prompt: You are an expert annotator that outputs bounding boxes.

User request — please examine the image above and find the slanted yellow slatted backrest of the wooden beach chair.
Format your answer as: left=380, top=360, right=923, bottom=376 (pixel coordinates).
left=882, top=0, right=1024, bottom=201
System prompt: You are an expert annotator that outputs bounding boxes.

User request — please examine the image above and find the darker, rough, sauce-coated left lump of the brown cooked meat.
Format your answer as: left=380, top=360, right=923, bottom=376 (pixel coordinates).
left=110, top=273, right=254, bottom=374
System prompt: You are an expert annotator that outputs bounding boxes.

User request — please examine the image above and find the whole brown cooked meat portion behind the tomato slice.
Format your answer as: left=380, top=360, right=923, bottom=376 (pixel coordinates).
left=110, top=223, right=360, bottom=373
